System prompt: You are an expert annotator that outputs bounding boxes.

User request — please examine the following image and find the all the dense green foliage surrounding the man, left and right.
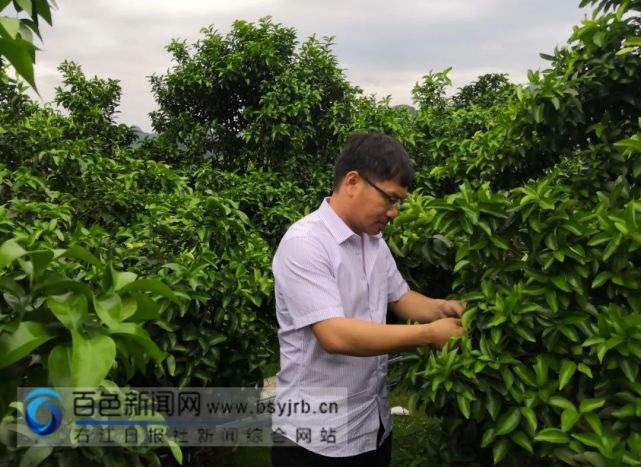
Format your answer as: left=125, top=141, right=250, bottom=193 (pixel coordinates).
left=0, top=0, right=641, bottom=466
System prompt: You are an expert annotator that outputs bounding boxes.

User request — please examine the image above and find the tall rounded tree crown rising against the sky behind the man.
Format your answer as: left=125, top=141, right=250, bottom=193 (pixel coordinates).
left=151, top=18, right=358, bottom=173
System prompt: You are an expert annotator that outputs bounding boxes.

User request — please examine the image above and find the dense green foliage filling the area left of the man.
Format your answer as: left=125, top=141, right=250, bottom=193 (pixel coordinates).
left=0, top=63, right=274, bottom=464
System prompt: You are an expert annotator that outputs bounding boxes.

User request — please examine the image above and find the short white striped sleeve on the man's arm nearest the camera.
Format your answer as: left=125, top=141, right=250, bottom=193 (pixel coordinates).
left=272, top=237, right=345, bottom=329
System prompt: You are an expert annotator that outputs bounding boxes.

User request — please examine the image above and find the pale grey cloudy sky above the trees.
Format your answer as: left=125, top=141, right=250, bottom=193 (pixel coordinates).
left=30, top=0, right=590, bottom=131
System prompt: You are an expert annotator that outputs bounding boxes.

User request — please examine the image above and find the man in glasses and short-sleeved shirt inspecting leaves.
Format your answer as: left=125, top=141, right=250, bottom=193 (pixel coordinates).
left=272, top=133, right=465, bottom=467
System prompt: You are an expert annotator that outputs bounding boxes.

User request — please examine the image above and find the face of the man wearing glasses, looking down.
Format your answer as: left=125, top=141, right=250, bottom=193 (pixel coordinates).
left=352, top=176, right=407, bottom=235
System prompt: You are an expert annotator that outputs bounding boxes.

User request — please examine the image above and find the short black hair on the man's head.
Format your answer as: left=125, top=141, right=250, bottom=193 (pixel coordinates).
left=334, top=133, right=414, bottom=189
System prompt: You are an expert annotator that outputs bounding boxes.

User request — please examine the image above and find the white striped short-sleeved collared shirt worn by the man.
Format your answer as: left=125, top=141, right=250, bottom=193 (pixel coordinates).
left=272, top=199, right=409, bottom=457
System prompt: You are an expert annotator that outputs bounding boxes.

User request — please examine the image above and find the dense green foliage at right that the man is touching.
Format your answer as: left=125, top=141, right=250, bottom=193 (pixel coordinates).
left=390, top=2, right=641, bottom=466
